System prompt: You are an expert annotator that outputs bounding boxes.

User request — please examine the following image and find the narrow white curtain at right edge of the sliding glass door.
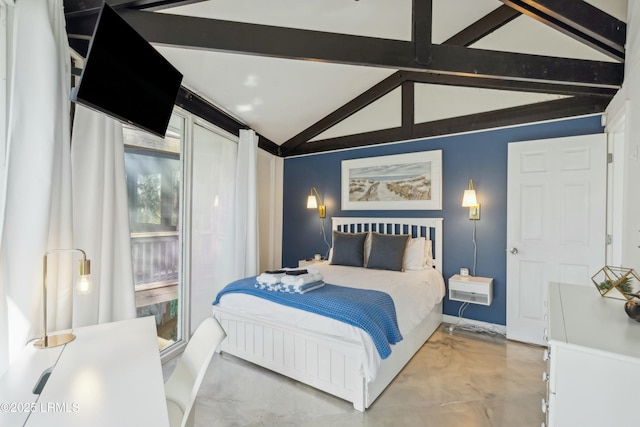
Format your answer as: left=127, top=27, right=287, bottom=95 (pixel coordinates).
left=235, top=129, right=260, bottom=278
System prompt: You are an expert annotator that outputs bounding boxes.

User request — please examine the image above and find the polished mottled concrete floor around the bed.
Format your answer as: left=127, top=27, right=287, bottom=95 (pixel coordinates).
left=165, top=325, right=546, bottom=427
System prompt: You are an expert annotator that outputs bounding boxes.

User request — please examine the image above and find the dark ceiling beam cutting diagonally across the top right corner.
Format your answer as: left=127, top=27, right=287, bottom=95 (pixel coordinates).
left=501, top=0, right=627, bottom=61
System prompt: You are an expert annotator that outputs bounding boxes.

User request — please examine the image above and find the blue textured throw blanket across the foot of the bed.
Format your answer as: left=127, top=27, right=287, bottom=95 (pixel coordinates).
left=213, top=276, right=402, bottom=359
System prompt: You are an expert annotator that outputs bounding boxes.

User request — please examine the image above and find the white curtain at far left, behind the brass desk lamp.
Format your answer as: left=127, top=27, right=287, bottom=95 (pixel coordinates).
left=0, top=0, right=73, bottom=372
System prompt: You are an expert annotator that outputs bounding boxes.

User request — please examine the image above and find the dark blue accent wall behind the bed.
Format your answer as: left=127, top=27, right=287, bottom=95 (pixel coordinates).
left=282, top=115, right=604, bottom=325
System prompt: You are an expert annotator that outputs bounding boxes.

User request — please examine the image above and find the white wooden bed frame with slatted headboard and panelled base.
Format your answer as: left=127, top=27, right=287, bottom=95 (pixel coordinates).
left=213, top=218, right=442, bottom=412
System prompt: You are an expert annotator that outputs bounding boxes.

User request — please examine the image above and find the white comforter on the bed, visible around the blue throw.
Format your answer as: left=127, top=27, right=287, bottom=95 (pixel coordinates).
left=214, top=262, right=445, bottom=381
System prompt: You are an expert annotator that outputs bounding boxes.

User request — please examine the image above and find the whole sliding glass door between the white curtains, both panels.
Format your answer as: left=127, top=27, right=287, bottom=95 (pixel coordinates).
left=124, top=111, right=238, bottom=357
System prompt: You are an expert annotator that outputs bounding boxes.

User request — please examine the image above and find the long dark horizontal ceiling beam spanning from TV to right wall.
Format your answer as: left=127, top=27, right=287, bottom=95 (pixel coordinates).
left=96, top=10, right=624, bottom=88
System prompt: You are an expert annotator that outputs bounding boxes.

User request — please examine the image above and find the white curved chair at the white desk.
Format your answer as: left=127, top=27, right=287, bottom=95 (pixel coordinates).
left=164, top=317, right=227, bottom=427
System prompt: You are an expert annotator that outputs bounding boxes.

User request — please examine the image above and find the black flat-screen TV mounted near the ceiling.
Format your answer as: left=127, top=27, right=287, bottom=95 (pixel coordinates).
left=71, top=3, right=182, bottom=137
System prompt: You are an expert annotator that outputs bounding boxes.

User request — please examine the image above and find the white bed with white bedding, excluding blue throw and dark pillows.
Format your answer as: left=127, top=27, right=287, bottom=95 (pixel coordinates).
left=213, top=217, right=444, bottom=411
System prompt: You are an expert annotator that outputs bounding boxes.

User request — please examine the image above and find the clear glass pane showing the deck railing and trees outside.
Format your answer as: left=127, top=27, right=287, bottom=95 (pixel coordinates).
left=124, top=119, right=183, bottom=348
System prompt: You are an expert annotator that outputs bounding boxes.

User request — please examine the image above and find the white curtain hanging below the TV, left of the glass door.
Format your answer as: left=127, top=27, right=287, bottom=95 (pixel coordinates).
left=71, top=105, right=136, bottom=326
